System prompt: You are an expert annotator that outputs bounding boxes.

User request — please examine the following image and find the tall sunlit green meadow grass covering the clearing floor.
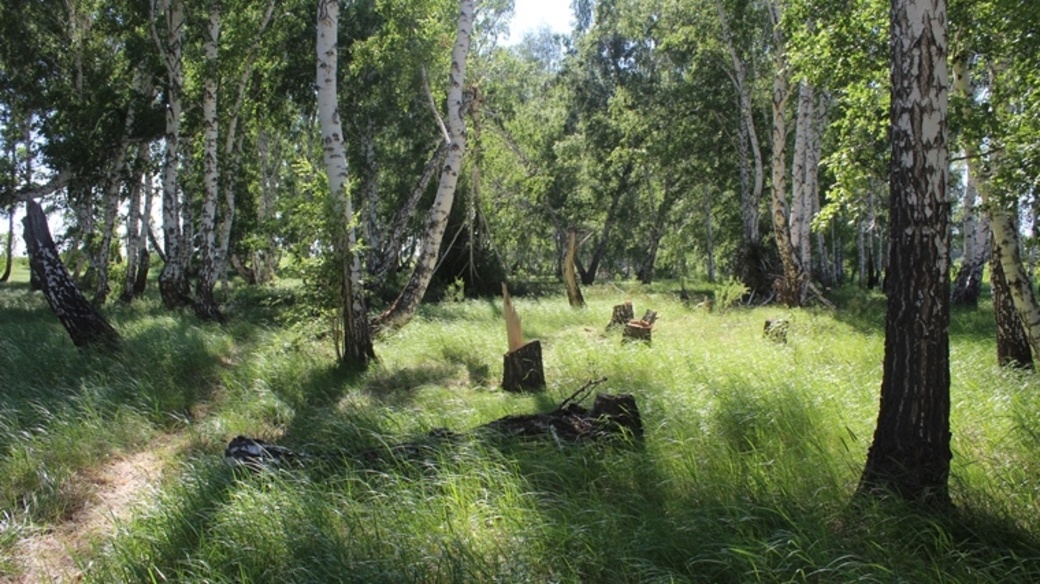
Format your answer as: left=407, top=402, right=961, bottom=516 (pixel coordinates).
left=0, top=268, right=1040, bottom=582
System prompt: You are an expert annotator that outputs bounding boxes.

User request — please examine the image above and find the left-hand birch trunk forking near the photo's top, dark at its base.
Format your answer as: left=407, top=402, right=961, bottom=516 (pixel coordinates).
left=152, top=0, right=191, bottom=309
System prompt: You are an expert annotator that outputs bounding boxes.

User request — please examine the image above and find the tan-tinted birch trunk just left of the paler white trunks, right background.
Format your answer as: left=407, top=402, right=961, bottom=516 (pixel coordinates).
left=769, top=0, right=809, bottom=307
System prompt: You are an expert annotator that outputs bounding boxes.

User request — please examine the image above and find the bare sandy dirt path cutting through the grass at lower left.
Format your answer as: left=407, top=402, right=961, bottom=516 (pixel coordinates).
left=0, top=435, right=186, bottom=584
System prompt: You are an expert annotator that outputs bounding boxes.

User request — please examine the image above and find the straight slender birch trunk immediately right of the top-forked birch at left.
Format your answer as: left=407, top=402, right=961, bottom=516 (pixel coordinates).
left=194, top=0, right=225, bottom=321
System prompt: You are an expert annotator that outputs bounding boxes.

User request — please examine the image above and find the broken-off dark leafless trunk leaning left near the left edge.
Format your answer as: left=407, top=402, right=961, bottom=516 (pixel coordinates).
left=22, top=201, right=120, bottom=349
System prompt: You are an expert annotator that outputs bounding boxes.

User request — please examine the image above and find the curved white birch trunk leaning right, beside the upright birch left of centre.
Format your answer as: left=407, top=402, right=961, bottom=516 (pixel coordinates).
left=376, top=0, right=474, bottom=327
